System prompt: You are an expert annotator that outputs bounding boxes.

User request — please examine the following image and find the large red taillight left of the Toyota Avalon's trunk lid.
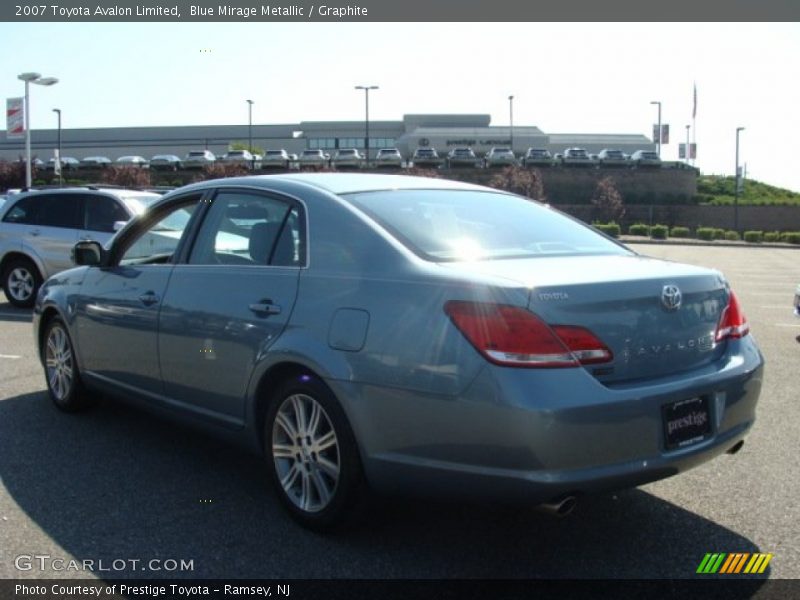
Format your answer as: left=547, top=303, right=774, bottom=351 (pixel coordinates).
left=444, top=301, right=613, bottom=368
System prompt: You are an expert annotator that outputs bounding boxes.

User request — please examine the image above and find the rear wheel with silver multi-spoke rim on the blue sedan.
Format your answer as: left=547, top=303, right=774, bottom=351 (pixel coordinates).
left=264, top=375, right=363, bottom=531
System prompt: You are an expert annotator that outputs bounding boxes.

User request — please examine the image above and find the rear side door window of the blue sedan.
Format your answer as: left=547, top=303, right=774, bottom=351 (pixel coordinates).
left=189, top=191, right=304, bottom=267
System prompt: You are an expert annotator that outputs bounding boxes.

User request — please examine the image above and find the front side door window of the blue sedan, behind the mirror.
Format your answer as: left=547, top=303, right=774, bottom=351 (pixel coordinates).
left=117, top=195, right=201, bottom=265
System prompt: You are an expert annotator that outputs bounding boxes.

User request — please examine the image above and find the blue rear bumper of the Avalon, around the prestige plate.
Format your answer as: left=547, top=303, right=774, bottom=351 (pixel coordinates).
left=331, top=338, right=763, bottom=504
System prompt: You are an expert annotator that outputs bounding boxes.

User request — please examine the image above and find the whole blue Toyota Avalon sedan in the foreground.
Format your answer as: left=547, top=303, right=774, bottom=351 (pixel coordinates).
left=33, top=173, right=763, bottom=528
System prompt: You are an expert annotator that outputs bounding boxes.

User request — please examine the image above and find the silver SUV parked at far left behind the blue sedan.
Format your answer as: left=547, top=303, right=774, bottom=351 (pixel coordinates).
left=0, top=187, right=160, bottom=308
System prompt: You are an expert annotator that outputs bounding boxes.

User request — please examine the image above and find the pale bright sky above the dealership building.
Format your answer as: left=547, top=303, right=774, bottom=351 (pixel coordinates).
left=0, top=22, right=800, bottom=192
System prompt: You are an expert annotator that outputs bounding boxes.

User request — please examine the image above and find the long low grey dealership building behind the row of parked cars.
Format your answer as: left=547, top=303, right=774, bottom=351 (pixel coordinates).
left=0, top=114, right=655, bottom=160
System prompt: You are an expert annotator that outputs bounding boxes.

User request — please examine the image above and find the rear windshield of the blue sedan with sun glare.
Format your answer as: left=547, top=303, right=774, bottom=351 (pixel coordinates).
left=343, top=190, right=629, bottom=262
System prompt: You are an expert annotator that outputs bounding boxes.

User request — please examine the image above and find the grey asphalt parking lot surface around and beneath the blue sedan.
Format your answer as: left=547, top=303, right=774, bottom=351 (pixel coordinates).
left=0, top=245, right=800, bottom=579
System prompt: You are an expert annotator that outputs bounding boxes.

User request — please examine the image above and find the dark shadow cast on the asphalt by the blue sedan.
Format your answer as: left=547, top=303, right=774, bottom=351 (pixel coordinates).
left=0, top=392, right=769, bottom=584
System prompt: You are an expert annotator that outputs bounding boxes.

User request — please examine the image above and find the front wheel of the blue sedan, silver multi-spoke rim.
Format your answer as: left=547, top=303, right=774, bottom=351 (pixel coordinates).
left=42, top=317, right=94, bottom=412
